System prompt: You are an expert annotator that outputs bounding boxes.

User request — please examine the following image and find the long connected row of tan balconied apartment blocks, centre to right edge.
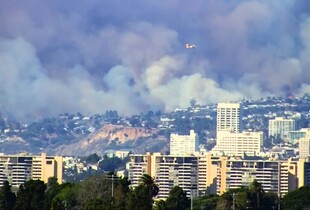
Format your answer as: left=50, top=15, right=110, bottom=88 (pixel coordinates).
left=127, top=152, right=310, bottom=198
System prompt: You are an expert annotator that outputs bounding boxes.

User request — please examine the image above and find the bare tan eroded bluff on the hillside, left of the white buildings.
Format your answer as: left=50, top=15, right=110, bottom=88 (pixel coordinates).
left=55, top=125, right=168, bottom=155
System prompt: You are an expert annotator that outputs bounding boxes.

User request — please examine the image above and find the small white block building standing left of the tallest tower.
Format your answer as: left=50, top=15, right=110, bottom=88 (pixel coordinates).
left=170, top=130, right=199, bottom=155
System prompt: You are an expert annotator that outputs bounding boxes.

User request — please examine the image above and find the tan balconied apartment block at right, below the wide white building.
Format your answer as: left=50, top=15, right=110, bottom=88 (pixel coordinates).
left=209, top=157, right=306, bottom=195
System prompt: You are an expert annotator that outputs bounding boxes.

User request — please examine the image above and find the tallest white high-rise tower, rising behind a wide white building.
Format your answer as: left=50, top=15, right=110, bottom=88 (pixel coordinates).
left=216, top=103, right=242, bottom=133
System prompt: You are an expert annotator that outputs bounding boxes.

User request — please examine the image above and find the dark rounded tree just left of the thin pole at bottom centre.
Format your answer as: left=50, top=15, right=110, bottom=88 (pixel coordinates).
left=166, top=186, right=190, bottom=210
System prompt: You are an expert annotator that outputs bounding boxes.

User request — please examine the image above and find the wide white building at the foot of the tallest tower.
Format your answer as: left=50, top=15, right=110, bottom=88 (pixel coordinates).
left=212, top=131, right=263, bottom=156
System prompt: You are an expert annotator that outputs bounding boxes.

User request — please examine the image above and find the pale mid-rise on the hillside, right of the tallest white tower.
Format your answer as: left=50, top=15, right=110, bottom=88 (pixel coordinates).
left=269, top=117, right=296, bottom=140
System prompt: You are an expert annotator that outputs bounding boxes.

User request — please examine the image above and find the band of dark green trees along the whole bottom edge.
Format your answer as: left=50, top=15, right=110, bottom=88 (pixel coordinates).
left=0, top=173, right=310, bottom=210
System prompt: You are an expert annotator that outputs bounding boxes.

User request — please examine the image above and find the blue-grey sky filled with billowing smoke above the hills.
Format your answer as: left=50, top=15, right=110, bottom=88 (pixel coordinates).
left=0, top=0, right=310, bottom=120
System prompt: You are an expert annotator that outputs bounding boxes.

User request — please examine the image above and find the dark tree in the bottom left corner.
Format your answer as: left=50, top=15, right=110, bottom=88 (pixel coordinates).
left=0, top=181, right=16, bottom=210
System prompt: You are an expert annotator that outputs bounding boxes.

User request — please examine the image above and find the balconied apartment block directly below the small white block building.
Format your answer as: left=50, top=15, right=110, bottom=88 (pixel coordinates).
left=127, top=153, right=198, bottom=198
